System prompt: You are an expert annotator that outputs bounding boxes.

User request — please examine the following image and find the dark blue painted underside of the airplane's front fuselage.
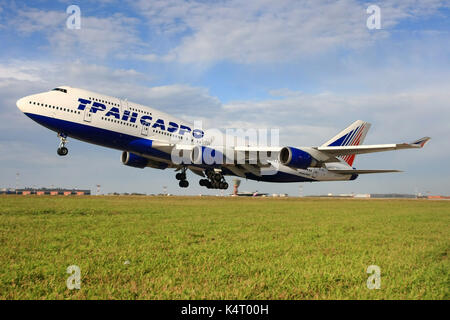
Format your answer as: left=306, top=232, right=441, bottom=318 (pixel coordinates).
left=25, top=113, right=170, bottom=160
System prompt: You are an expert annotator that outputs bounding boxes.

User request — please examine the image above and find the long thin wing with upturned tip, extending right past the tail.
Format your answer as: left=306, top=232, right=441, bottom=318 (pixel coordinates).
left=317, top=137, right=431, bottom=156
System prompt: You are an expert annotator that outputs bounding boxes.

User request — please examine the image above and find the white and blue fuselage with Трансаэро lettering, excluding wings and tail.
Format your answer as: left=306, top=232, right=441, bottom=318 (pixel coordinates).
left=17, top=86, right=355, bottom=182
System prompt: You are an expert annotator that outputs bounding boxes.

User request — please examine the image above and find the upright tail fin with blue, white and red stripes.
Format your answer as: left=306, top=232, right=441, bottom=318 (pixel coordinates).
left=322, top=120, right=370, bottom=166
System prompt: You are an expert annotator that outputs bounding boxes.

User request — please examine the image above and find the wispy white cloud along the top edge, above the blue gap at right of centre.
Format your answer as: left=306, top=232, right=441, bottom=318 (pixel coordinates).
left=137, top=0, right=445, bottom=64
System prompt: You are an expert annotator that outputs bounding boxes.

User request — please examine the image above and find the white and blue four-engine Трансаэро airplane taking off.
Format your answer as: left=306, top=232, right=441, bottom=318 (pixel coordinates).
left=17, top=86, right=430, bottom=189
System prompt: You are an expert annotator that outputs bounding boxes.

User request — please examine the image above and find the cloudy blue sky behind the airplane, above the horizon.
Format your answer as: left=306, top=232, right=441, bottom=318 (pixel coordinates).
left=0, top=0, right=450, bottom=196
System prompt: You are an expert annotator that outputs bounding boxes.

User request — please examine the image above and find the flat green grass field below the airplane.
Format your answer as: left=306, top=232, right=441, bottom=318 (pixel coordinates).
left=0, top=196, right=450, bottom=299
